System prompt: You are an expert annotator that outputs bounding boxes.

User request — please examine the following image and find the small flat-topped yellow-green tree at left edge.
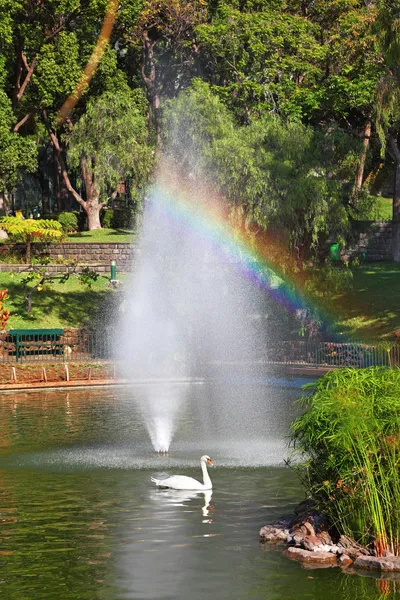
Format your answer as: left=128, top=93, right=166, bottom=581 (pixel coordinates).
left=0, top=217, right=63, bottom=264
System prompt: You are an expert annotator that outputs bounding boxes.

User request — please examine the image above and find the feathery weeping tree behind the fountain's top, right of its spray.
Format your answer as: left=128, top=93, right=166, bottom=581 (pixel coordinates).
left=166, top=80, right=358, bottom=258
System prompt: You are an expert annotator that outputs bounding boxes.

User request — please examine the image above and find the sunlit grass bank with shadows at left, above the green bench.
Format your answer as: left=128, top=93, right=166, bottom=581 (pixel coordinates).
left=0, top=273, right=123, bottom=329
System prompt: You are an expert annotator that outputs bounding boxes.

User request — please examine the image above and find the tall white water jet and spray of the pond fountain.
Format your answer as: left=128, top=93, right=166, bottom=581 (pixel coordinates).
left=117, top=165, right=261, bottom=454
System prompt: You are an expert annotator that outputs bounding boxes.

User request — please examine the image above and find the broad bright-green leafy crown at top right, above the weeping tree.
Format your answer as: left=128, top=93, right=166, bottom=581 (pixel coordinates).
left=196, top=0, right=381, bottom=121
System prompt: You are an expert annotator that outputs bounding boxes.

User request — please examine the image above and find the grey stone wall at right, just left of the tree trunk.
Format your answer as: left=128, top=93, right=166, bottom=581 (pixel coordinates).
left=341, top=221, right=392, bottom=262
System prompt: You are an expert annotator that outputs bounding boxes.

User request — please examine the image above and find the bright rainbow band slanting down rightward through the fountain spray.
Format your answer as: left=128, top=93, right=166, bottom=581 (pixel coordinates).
left=150, top=174, right=337, bottom=338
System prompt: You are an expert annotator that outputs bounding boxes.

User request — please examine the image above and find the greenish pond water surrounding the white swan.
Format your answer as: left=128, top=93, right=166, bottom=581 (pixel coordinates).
left=0, top=380, right=396, bottom=600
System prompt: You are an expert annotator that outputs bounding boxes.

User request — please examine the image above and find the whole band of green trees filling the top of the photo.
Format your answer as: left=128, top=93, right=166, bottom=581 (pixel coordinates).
left=0, top=0, right=400, bottom=258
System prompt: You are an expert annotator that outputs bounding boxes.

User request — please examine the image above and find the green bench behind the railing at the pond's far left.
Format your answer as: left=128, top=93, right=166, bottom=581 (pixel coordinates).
left=8, top=329, right=64, bottom=361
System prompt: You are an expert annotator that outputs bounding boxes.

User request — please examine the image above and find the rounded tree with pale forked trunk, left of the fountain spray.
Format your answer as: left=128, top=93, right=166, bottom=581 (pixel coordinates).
left=47, top=86, right=152, bottom=231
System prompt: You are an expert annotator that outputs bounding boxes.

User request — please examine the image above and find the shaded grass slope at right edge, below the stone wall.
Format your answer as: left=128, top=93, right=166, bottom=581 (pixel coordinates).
left=329, top=263, right=400, bottom=341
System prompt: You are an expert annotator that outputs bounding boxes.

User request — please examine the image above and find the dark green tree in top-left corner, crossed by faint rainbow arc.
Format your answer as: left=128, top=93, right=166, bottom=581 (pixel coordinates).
left=0, top=0, right=134, bottom=209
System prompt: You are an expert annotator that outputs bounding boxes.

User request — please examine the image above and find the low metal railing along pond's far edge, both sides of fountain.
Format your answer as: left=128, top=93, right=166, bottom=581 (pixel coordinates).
left=0, top=330, right=400, bottom=368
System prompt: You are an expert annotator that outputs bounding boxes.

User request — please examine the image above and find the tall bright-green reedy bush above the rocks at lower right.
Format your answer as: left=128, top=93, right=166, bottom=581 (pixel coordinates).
left=291, top=367, right=400, bottom=556
